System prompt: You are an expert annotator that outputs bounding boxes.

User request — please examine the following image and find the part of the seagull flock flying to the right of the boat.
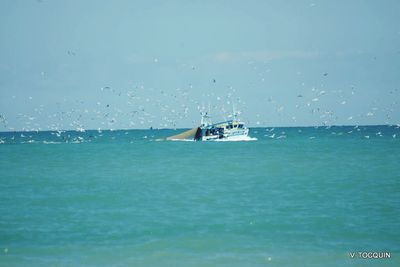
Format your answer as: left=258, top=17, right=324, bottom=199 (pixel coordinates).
left=248, top=61, right=399, bottom=130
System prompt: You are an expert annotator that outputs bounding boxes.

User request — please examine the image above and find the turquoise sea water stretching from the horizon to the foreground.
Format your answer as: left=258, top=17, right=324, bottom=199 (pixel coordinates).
left=0, top=126, right=400, bottom=267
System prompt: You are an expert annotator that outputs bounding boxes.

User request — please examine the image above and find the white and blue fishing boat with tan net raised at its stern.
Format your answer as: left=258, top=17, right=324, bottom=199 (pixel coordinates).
left=167, top=112, right=256, bottom=141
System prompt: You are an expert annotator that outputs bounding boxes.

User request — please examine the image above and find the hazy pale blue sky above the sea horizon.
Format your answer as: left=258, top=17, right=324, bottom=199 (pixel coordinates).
left=0, top=0, right=400, bottom=131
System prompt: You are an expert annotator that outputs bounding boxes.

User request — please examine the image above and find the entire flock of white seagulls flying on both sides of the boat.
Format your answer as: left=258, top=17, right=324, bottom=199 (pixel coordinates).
left=0, top=57, right=400, bottom=141
